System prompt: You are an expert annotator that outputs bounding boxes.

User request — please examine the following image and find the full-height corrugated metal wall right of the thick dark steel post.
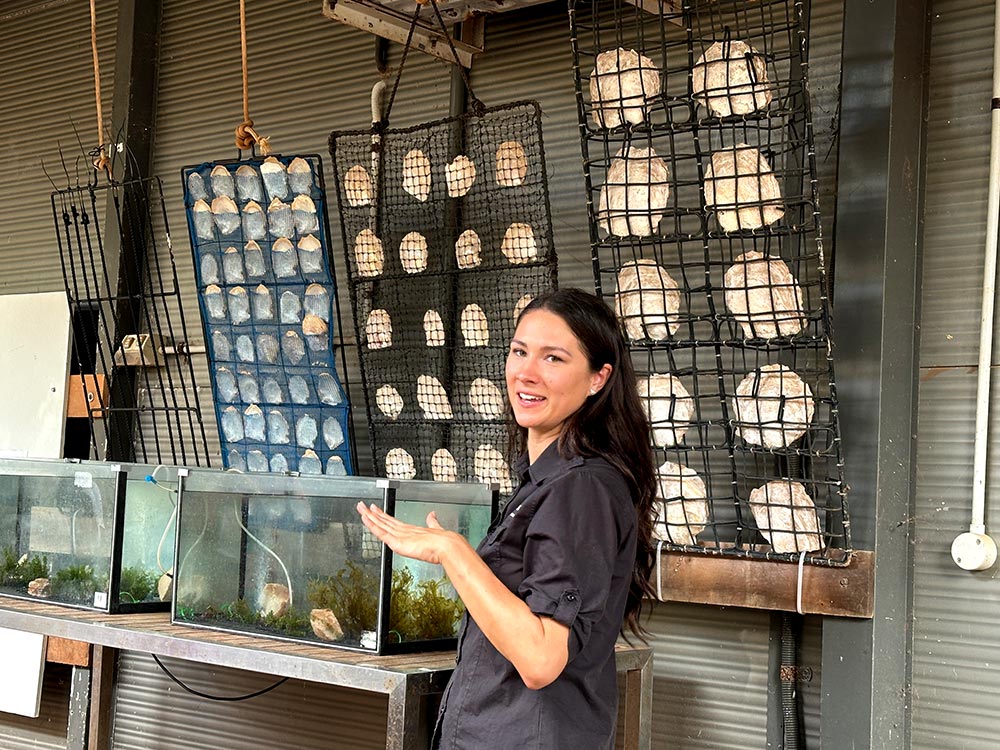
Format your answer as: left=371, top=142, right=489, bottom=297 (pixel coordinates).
left=911, top=0, right=1000, bottom=750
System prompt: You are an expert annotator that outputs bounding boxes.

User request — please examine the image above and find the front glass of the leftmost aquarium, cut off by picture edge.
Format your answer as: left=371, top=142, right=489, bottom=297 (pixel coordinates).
left=0, top=459, right=124, bottom=610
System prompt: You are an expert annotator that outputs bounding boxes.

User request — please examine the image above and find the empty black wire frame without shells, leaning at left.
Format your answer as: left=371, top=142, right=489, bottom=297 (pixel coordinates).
left=51, top=178, right=211, bottom=466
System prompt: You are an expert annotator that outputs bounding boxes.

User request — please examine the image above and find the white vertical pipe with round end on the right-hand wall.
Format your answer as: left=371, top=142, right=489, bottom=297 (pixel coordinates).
left=951, top=0, right=1000, bottom=570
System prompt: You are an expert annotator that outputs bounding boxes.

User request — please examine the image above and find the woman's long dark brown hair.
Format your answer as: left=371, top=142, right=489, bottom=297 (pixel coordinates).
left=507, top=288, right=657, bottom=638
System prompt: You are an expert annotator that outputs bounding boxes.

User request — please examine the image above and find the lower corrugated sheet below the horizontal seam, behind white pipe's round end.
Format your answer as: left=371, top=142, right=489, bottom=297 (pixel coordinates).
left=912, top=368, right=1000, bottom=750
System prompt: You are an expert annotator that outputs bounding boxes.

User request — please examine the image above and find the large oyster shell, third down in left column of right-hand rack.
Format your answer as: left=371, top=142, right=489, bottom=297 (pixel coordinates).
left=615, top=258, right=681, bottom=341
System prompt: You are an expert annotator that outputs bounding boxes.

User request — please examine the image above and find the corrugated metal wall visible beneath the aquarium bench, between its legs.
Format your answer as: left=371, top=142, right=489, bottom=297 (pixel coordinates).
left=112, top=653, right=387, bottom=750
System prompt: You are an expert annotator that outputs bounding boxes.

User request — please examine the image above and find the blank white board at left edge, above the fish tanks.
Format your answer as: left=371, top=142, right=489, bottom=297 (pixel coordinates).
left=0, top=292, right=70, bottom=458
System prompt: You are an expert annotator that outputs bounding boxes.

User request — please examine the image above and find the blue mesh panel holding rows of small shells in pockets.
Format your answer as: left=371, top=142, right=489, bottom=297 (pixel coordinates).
left=181, top=154, right=356, bottom=474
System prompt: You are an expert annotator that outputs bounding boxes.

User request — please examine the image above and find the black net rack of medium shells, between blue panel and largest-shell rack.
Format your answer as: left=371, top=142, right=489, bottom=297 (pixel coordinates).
left=330, top=101, right=556, bottom=492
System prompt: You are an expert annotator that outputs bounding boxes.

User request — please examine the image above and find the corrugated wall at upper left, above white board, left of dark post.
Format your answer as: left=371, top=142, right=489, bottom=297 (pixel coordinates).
left=0, top=0, right=117, bottom=294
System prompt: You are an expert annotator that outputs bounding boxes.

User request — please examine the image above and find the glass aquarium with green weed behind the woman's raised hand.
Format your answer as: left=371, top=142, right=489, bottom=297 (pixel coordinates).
left=171, top=469, right=499, bottom=654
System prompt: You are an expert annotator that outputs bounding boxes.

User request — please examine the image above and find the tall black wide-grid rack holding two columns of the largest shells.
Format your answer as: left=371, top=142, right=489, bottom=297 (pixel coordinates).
left=570, top=0, right=851, bottom=565
